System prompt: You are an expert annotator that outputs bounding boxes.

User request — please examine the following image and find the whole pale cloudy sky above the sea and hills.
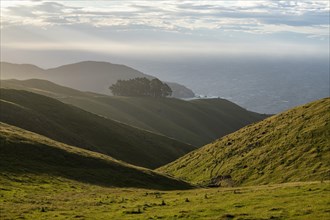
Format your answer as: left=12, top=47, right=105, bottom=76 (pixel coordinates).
left=1, top=0, right=330, bottom=66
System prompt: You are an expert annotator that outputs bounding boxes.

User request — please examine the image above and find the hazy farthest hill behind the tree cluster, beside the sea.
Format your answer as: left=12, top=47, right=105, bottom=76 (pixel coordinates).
left=1, top=61, right=195, bottom=98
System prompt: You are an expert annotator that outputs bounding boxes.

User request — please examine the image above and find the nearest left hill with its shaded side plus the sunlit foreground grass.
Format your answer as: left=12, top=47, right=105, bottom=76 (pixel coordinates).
left=0, top=123, right=330, bottom=220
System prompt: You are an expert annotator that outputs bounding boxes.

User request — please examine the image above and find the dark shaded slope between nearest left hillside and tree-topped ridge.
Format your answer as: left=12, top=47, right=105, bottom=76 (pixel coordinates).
left=0, top=89, right=195, bottom=168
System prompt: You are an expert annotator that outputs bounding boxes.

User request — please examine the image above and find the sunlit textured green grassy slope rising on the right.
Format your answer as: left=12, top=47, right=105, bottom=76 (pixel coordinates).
left=159, top=98, right=330, bottom=185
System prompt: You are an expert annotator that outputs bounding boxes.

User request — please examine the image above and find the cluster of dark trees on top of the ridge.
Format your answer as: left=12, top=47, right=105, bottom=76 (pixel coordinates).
left=109, top=77, right=172, bottom=97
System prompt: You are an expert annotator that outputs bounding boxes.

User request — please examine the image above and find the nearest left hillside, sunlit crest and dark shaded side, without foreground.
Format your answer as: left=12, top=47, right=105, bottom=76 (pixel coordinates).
left=0, top=123, right=189, bottom=189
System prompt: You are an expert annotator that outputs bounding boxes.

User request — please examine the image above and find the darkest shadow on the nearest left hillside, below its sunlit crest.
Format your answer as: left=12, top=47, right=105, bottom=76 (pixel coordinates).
left=0, top=140, right=192, bottom=190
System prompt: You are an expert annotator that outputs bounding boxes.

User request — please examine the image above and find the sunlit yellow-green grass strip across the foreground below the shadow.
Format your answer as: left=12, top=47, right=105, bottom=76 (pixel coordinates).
left=0, top=174, right=330, bottom=219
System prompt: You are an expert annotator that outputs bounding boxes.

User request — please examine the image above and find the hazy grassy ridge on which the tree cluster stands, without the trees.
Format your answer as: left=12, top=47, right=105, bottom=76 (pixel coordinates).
left=1, top=79, right=267, bottom=146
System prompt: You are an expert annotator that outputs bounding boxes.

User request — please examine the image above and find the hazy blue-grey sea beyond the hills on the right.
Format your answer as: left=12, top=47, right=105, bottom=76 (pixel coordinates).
left=129, top=58, right=329, bottom=113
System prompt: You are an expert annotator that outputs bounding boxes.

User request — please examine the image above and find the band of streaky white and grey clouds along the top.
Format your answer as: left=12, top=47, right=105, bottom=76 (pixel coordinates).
left=2, top=0, right=330, bottom=29
